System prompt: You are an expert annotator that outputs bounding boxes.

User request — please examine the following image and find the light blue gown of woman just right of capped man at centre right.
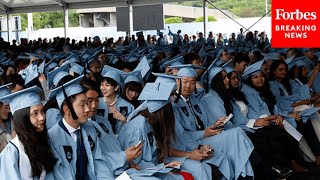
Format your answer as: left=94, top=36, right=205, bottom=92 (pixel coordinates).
left=201, top=89, right=234, bottom=129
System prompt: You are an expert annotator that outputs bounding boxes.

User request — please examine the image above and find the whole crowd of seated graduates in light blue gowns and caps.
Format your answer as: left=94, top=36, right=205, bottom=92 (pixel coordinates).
left=0, top=29, right=320, bottom=180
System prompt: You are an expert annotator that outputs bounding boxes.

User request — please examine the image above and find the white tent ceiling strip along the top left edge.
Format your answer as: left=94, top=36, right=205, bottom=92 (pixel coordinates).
left=0, top=0, right=189, bottom=14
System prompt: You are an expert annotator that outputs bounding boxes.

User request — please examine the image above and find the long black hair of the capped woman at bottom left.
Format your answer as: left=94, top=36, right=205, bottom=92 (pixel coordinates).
left=13, top=107, right=57, bottom=177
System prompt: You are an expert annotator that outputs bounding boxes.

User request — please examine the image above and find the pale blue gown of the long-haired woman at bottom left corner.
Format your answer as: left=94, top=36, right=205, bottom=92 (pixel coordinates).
left=0, top=143, right=56, bottom=180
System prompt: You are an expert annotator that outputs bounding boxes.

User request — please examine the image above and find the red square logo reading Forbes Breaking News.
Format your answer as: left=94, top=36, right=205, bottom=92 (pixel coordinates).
left=271, top=0, right=320, bottom=48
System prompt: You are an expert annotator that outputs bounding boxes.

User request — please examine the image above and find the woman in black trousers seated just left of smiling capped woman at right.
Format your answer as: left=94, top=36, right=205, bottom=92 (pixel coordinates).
left=225, top=64, right=299, bottom=179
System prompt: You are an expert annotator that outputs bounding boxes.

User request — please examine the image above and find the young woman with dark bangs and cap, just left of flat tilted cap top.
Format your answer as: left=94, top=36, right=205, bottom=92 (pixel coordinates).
left=122, top=73, right=143, bottom=108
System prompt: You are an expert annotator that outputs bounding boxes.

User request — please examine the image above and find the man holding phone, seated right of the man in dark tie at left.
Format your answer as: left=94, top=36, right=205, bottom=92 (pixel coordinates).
left=81, top=78, right=143, bottom=176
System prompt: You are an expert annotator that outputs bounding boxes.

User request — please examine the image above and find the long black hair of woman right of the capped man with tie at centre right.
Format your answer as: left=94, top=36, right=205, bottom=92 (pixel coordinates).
left=210, top=71, right=233, bottom=114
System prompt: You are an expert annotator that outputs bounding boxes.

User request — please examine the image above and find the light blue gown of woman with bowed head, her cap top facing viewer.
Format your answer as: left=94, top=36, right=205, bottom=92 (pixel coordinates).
left=118, top=115, right=185, bottom=179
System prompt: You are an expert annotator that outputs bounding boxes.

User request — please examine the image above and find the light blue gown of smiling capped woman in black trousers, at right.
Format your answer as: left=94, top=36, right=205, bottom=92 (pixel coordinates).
left=241, top=85, right=297, bottom=127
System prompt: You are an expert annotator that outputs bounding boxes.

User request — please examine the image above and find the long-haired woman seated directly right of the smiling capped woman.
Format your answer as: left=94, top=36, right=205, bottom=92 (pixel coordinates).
left=269, top=61, right=320, bottom=166
